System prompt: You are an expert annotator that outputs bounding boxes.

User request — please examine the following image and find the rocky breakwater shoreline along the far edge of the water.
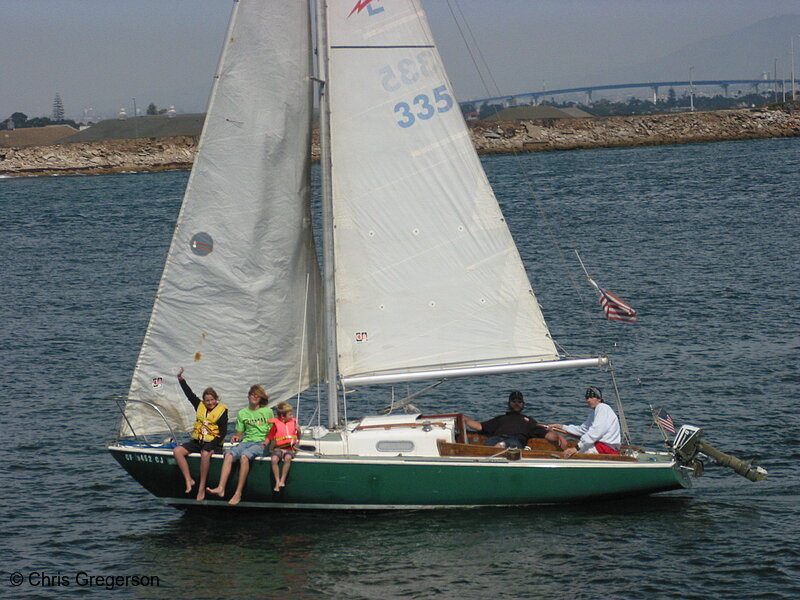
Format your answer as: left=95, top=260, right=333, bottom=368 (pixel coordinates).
left=0, top=109, right=800, bottom=176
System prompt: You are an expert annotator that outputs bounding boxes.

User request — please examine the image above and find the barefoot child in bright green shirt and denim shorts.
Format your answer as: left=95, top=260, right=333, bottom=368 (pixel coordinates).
left=206, top=385, right=275, bottom=505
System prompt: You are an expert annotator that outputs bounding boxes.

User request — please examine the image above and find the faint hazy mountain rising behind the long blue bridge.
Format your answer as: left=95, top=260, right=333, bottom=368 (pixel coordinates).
left=586, top=13, right=800, bottom=85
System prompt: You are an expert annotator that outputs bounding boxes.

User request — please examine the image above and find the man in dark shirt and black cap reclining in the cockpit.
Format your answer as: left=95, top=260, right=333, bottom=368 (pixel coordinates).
left=464, top=391, right=567, bottom=450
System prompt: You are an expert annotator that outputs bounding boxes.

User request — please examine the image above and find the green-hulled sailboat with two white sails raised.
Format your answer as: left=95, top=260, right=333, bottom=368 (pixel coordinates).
left=109, top=0, right=760, bottom=509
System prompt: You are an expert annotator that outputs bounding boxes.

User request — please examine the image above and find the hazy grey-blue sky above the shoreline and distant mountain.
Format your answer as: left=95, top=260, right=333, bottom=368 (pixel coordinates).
left=6, top=0, right=800, bottom=120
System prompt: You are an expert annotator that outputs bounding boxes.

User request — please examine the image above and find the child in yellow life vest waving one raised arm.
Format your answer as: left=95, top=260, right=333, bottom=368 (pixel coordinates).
left=172, top=367, right=228, bottom=500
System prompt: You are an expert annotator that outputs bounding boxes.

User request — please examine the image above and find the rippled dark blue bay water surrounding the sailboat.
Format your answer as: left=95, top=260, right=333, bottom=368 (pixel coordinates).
left=0, top=139, right=800, bottom=600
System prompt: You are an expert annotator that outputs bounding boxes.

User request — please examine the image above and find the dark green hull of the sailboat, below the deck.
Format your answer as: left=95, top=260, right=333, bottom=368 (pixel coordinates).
left=109, top=445, right=689, bottom=510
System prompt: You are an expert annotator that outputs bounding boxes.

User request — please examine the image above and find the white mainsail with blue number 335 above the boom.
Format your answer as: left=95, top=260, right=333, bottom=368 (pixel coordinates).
left=327, top=0, right=558, bottom=382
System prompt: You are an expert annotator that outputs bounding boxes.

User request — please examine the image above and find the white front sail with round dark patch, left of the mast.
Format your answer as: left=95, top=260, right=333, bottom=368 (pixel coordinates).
left=123, top=2, right=324, bottom=434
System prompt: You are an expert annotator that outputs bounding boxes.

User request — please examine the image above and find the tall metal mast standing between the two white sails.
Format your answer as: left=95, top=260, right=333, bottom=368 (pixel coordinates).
left=316, top=0, right=339, bottom=429
